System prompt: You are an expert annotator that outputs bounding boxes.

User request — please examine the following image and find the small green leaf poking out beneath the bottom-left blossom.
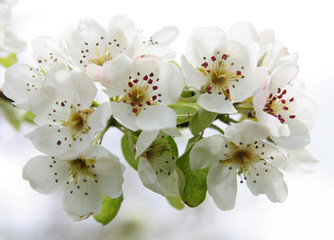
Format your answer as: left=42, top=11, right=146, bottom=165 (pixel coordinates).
left=94, top=195, right=123, bottom=225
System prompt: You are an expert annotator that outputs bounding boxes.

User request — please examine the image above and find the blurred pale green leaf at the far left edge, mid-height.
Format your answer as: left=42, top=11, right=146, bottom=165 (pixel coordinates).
left=0, top=99, right=25, bottom=130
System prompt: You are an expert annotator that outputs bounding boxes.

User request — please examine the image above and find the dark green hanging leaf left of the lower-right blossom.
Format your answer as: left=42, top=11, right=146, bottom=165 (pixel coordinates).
left=176, top=135, right=209, bottom=207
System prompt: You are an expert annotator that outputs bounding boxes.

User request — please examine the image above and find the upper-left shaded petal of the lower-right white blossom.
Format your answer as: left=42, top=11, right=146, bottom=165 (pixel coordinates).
left=189, top=135, right=225, bottom=170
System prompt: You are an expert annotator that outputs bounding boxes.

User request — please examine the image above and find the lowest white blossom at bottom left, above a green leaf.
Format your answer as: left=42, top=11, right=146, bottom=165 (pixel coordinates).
left=23, top=145, right=124, bottom=220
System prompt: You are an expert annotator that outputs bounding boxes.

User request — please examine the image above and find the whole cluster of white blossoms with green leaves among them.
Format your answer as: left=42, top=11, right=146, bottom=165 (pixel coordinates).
left=3, top=15, right=317, bottom=220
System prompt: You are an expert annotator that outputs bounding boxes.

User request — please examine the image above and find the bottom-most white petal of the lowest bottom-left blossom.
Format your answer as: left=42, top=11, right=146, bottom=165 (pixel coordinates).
left=63, top=178, right=102, bottom=220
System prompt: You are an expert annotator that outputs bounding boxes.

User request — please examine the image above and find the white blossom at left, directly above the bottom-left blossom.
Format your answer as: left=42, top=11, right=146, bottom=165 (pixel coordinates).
left=26, top=71, right=111, bottom=158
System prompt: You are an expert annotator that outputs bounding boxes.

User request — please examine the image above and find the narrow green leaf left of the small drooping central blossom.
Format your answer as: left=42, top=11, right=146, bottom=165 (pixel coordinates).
left=121, top=130, right=139, bottom=170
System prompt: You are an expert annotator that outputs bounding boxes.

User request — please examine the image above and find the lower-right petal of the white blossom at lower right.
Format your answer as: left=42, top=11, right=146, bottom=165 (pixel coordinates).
left=247, top=163, right=288, bottom=202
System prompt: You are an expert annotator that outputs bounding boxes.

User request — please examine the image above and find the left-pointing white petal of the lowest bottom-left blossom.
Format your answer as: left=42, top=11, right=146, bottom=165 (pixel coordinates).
left=23, top=156, right=69, bottom=194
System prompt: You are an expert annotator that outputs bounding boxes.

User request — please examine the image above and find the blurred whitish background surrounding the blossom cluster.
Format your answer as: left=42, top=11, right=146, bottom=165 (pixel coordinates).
left=0, top=0, right=334, bottom=240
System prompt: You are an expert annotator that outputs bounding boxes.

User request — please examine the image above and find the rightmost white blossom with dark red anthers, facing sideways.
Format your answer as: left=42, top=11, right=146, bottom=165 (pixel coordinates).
left=253, top=63, right=317, bottom=150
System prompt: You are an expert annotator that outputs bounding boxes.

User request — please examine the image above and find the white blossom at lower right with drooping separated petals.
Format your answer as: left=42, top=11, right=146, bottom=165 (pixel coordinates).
left=190, top=122, right=288, bottom=210
